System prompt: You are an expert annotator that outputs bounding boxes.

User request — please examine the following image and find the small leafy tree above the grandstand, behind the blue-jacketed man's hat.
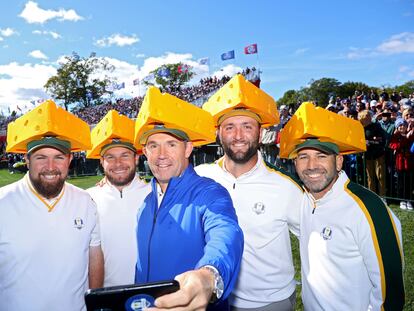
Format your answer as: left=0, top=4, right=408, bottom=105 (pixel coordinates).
left=144, top=63, right=194, bottom=92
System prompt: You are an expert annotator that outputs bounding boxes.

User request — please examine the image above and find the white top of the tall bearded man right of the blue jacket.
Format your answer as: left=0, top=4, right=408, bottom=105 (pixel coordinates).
left=196, top=153, right=303, bottom=308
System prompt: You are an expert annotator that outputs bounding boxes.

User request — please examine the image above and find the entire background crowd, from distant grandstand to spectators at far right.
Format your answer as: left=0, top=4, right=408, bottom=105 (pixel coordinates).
left=0, top=73, right=414, bottom=210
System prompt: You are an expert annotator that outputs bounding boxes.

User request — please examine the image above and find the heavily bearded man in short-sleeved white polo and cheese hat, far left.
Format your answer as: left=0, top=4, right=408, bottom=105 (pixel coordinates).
left=0, top=102, right=103, bottom=311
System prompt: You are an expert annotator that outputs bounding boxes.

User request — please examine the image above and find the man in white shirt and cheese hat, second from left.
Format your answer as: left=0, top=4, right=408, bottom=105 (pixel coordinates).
left=87, top=110, right=151, bottom=286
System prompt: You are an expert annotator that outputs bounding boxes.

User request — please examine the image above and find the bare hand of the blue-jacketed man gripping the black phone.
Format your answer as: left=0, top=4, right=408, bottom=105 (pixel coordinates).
left=147, top=269, right=214, bottom=311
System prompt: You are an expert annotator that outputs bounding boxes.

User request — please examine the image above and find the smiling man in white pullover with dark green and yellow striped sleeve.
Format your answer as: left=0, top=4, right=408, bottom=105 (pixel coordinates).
left=281, top=104, right=404, bottom=310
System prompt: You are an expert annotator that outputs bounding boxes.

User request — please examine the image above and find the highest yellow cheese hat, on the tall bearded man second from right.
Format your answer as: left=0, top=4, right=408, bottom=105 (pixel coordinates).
left=203, top=74, right=279, bottom=127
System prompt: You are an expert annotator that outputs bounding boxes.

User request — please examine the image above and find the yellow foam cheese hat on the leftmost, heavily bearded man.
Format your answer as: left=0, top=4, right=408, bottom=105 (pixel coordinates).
left=6, top=100, right=91, bottom=153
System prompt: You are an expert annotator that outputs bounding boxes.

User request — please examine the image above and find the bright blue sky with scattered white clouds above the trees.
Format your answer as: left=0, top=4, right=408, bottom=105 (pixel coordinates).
left=0, top=0, right=414, bottom=114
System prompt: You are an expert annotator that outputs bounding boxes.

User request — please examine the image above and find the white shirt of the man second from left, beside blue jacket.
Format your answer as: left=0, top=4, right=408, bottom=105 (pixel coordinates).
left=87, top=175, right=151, bottom=286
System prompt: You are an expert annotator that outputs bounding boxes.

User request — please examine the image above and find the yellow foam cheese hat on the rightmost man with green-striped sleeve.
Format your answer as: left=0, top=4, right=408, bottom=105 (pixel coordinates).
left=280, top=102, right=366, bottom=158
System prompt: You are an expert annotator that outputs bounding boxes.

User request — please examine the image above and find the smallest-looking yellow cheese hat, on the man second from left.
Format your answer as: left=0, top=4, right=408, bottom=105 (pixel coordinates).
left=86, top=110, right=136, bottom=159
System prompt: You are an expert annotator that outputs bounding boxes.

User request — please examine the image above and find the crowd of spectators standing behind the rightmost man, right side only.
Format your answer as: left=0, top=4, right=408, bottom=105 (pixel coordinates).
left=263, top=90, right=414, bottom=210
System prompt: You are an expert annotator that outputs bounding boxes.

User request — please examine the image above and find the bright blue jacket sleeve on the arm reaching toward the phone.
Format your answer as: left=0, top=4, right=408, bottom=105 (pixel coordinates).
left=196, top=184, right=244, bottom=299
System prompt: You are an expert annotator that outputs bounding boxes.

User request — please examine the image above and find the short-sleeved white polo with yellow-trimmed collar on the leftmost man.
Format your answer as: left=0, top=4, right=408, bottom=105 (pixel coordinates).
left=0, top=175, right=100, bottom=311
